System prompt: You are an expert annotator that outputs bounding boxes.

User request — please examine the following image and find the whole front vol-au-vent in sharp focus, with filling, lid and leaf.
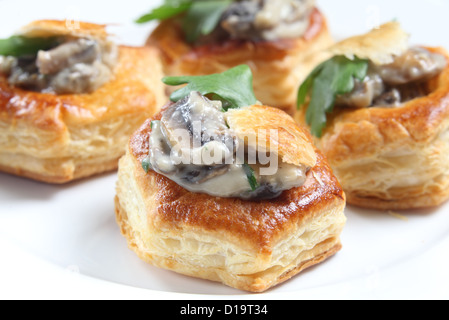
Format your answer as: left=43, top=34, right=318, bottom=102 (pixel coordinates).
left=116, top=66, right=346, bottom=292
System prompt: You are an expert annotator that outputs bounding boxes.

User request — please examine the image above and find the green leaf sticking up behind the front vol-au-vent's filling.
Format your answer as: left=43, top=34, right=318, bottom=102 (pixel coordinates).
left=162, top=65, right=257, bottom=110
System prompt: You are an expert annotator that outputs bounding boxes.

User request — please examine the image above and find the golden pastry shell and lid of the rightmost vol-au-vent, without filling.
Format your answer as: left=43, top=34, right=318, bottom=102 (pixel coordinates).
left=296, top=23, right=449, bottom=210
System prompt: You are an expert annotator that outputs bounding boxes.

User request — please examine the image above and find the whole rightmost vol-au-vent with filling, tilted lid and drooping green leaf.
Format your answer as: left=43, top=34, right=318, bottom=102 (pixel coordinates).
left=296, top=22, right=449, bottom=210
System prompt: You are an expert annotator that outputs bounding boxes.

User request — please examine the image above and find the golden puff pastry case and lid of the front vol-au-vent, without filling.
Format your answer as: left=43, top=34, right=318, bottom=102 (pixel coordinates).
left=115, top=106, right=346, bottom=292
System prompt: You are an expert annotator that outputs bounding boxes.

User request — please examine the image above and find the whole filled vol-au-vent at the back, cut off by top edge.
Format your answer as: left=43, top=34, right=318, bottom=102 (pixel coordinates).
left=138, top=0, right=333, bottom=113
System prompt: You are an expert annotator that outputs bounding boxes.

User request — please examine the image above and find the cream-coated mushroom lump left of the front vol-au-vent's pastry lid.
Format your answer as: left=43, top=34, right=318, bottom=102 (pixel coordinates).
left=150, top=92, right=237, bottom=183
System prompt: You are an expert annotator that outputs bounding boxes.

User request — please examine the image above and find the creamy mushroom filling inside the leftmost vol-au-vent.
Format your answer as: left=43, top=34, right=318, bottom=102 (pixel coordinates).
left=0, top=38, right=118, bottom=94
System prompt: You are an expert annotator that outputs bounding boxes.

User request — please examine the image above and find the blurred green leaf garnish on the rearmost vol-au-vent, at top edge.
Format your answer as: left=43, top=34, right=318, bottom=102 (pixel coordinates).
left=136, top=0, right=233, bottom=43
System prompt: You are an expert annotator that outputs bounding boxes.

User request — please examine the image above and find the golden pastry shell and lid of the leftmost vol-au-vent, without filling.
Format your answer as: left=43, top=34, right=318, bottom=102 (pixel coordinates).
left=0, top=21, right=165, bottom=184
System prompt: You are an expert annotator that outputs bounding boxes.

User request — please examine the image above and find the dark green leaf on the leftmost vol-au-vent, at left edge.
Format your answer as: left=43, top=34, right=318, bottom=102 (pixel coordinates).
left=0, top=36, right=58, bottom=57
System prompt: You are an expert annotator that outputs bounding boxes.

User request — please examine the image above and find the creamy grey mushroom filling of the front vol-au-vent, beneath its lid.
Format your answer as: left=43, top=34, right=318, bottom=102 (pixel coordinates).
left=148, top=92, right=308, bottom=200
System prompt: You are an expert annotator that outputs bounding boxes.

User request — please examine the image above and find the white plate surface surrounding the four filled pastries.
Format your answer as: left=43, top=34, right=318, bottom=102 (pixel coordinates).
left=0, top=0, right=449, bottom=299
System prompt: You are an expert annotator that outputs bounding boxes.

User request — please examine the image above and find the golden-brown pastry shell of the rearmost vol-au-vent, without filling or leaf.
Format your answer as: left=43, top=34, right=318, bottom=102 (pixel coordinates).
left=147, top=8, right=333, bottom=114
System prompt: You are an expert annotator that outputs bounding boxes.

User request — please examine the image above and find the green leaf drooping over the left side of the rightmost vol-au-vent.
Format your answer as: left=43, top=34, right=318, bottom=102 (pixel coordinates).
left=298, top=56, right=369, bottom=138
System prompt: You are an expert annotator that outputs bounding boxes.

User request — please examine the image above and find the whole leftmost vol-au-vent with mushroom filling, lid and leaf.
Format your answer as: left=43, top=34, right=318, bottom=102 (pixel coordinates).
left=0, top=21, right=165, bottom=183
